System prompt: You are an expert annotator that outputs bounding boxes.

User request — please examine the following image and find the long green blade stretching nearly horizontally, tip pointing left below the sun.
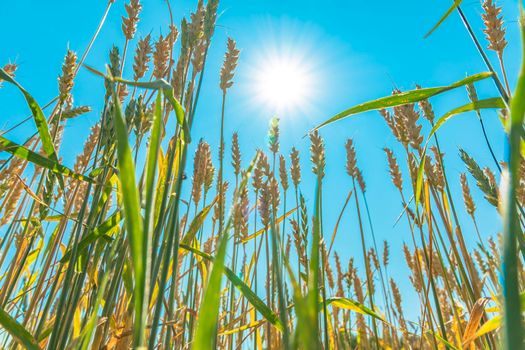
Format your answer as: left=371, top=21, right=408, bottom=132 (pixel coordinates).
left=314, top=72, right=493, bottom=130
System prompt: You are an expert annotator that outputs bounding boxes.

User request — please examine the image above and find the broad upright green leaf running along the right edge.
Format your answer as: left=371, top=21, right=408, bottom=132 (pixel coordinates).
left=501, top=7, right=525, bottom=350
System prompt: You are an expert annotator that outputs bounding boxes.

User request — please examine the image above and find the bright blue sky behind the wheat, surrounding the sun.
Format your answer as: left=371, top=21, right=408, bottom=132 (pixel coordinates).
left=0, top=0, right=520, bottom=322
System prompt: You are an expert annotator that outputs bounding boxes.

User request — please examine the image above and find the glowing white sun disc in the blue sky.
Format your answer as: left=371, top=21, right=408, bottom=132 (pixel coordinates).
left=255, top=54, right=312, bottom=112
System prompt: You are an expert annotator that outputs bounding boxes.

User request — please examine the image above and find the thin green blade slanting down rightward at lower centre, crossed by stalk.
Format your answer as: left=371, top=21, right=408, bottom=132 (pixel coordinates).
left=180, top=243, right=284, bottom=331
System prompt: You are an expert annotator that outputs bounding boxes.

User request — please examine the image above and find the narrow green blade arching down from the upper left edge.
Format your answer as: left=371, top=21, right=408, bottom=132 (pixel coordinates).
left=0, top=68, right=58, bottom=161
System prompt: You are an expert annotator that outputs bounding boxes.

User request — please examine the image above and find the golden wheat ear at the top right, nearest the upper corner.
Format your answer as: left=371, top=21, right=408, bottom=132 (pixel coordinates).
left=481, top=0, right=507, bottom=57
